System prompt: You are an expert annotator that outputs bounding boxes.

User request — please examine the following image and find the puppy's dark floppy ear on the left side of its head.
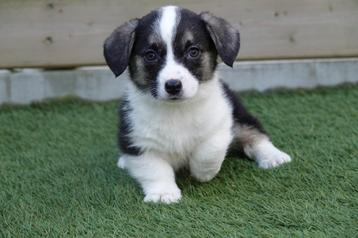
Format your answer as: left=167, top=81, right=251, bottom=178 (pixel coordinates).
left=103, top=19, right=139, bottom=77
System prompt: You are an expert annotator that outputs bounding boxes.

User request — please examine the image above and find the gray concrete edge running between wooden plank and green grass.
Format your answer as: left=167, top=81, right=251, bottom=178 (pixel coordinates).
left=0, top=58, right=358, bottom=105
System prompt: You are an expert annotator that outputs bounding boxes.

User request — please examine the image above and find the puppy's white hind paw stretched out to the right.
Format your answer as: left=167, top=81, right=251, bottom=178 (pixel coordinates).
left=257, top=147, right=292, bottom=169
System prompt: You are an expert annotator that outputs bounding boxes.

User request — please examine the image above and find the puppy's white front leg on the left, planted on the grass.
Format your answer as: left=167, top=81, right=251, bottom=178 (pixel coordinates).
left=118, top=153, right=181, bottom=203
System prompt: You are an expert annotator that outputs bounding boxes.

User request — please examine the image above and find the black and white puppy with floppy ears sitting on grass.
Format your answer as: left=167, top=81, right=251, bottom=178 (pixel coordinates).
left=104, top=6, right=291, bottom=203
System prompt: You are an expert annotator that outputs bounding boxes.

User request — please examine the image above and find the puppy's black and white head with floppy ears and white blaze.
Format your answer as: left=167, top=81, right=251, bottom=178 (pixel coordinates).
left=104, top=6, right=240, bottom=100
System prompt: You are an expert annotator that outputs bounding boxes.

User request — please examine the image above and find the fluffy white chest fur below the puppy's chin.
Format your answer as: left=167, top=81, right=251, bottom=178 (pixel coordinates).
left=124, top=79, right=233, bottom=167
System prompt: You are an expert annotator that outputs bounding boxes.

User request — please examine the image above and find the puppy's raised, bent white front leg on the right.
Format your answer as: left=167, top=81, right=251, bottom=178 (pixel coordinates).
left=189, top=130, right=232, bottom=182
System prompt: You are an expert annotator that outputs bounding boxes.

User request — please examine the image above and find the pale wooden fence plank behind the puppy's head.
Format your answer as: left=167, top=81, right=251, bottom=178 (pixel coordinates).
left=0, top=0, right=358, bottom=68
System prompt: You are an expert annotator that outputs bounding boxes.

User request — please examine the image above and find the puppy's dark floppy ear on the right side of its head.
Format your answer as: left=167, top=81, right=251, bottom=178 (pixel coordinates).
left=200, top=12, right=240, bottom=67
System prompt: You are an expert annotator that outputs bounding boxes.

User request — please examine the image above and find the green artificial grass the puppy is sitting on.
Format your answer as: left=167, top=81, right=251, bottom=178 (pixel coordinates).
left=0, top=86, right=358, bottom=237
